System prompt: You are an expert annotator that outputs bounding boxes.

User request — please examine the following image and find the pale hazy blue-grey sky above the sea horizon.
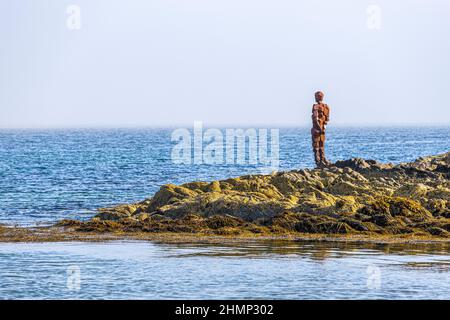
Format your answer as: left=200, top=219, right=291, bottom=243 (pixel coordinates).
left=0, top=0, right=450, bottom=127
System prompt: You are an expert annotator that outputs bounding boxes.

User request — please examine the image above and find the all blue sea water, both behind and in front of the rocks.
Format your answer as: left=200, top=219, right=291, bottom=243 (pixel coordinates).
left=0, top=126, right=450, bottom=299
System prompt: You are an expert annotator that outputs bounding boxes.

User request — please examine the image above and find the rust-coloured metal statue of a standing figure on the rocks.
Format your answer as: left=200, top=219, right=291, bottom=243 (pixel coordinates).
left=311, top=91, right=330, bottom=167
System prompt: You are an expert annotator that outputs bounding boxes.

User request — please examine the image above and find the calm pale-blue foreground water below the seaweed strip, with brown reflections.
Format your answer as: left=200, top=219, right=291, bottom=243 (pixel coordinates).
left=0, top=241, right=450, bottom=299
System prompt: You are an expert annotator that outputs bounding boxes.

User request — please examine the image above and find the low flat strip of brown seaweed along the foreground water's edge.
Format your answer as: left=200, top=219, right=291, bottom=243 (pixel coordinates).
left=0, top=226, right=450, bottom=247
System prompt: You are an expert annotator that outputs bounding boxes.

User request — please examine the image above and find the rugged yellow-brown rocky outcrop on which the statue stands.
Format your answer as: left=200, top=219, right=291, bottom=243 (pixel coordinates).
left=63, top=153, right=450, bottom=237
